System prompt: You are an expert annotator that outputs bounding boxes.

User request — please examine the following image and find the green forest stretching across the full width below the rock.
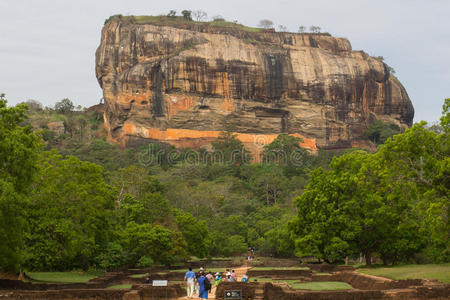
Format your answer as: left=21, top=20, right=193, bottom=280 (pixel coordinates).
left=0, top=94, right=450, bottom=272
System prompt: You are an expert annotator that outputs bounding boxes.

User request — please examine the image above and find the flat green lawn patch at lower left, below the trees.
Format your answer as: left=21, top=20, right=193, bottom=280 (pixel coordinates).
left=27, top=271, right=104, bottom=283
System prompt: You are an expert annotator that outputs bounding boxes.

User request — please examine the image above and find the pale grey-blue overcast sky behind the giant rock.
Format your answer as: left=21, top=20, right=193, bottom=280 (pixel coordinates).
left=0, top=0, right=450, bottom=122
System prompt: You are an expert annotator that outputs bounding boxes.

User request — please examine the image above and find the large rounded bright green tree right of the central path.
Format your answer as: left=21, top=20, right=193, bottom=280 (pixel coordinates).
left=290, top=151, right=423, bottom=265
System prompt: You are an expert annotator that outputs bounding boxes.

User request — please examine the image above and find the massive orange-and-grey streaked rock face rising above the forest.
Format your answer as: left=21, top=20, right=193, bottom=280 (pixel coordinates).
left=96, top=19, right=414, bottom=154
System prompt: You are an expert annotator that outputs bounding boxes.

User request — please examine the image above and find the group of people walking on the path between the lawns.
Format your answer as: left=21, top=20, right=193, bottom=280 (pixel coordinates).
left=184, top=268, right=248, bottom=299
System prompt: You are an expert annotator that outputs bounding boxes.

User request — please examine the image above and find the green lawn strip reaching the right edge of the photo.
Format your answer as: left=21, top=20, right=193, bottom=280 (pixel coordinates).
left=358, top=263, right=450, bottom=283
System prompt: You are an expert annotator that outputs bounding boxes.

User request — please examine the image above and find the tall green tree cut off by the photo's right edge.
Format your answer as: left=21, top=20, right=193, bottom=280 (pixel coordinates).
left=379, top=122, right=450, bottom=262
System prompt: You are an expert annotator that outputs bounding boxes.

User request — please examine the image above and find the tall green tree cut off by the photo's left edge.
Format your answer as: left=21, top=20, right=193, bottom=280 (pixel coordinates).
left=0, top=94, right=42, bottom=272
